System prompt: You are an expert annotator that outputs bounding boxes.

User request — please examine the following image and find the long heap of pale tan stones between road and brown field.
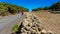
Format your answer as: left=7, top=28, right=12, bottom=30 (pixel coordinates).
left=12, top=14, right=53, bottom=34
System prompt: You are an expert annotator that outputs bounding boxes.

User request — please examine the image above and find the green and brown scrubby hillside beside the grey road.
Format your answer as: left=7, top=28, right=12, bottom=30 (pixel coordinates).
left=0, top=2, right=29, bottom=16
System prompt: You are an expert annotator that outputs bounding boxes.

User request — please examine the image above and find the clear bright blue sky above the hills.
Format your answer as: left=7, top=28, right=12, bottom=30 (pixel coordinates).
left=0, top=0, right=60, bottom=10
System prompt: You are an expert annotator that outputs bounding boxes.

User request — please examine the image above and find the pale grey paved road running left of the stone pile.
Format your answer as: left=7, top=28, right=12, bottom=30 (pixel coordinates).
left=0, top=14, right=24, bottom=34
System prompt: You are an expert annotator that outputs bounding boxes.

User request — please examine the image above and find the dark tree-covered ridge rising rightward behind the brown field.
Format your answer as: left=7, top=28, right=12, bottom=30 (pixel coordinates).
left=32, top=1, right=60, bottom=11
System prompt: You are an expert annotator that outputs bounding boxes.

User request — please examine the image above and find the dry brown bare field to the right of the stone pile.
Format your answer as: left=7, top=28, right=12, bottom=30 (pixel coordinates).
left=30, top=12, right=60, bottom=34
